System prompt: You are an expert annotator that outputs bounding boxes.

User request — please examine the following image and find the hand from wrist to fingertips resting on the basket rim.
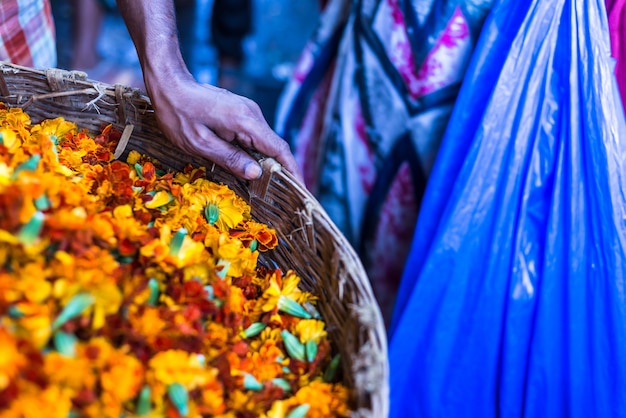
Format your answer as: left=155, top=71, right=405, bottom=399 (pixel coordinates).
left=148, top=79, right=302, bottom=181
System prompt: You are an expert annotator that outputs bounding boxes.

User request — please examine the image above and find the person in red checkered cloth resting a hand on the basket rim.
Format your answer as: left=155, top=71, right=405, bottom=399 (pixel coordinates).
left=0, top=0, right=299, bottom=180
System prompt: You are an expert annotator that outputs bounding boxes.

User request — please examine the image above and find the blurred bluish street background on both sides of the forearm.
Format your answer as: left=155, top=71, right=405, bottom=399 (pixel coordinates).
left=51, top=0, right=320, bottom=126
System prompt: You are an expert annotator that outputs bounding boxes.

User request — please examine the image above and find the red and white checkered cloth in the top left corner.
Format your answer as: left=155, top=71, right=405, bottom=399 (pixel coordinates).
left=0, top=0, right=57, bottom=69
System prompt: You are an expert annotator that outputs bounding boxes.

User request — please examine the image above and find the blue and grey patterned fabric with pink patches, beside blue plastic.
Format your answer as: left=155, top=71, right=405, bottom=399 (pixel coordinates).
left=276, top=0, right=491, bottom=320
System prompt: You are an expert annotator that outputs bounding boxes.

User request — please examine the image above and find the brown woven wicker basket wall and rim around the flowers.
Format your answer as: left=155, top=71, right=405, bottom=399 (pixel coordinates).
left=0, top=62, right=389, bottom=418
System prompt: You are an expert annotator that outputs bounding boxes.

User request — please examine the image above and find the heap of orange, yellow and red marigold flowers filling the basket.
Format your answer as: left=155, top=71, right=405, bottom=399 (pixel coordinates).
left=0, top=104, right=350, bottom=418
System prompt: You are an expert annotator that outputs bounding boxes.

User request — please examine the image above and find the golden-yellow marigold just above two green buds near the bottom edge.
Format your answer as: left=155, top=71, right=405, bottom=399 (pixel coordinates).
left=148, top=350, right=211, bottom=389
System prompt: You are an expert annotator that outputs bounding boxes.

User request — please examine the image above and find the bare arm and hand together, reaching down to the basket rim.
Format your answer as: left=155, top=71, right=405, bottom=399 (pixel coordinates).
left=117, top=0, right=302, bottom=181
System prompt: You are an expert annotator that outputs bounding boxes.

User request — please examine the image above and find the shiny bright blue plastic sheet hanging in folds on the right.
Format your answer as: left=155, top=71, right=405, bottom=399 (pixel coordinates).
left=389, top=0, right=626, bottom=418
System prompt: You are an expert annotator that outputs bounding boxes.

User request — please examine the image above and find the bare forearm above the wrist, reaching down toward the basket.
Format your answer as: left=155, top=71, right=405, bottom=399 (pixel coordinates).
left=117, top=0, right=193, bottom=93
